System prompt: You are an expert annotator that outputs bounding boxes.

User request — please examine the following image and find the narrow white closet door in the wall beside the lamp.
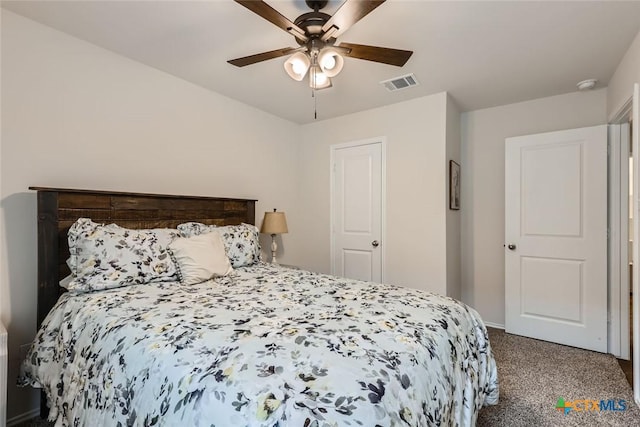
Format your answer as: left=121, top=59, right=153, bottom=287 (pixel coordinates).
left=331, top=140, right=384, bottom=282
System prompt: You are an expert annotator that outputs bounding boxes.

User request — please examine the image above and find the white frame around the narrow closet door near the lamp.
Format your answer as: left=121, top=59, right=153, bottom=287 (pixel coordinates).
left=329, top=136, right=387, bottom=283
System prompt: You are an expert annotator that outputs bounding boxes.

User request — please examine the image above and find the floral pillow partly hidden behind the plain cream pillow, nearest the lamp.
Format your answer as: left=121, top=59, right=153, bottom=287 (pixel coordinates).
left=178, top=222, right=260, bottom=268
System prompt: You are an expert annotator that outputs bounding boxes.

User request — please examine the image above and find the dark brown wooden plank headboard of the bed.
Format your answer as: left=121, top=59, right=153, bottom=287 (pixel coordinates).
left=29, top=187, right=256, bottom=327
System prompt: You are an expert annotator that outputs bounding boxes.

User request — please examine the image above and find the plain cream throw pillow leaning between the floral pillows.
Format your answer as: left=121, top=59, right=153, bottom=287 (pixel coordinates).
left=168, top=232, right=233, bottom=285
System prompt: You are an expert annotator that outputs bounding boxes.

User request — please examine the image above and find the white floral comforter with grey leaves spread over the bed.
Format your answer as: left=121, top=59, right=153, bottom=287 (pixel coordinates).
left=19, top=264, right=498, bottom=427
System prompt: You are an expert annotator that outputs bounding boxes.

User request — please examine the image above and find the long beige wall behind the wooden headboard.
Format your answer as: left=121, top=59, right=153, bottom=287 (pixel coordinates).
left=0, top=10, right=299, bottom=418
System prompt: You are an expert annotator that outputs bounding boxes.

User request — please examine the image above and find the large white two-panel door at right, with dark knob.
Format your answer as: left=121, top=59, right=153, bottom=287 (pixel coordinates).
left=505, top=125, right=607, bottom=352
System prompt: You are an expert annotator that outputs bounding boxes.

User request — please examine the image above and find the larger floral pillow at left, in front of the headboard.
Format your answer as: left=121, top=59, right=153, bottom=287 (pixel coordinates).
left=67, top=218, right=179, bottom=293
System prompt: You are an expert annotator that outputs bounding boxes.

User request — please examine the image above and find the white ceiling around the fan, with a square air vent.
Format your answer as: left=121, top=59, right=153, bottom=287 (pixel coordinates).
left=2, top=0, right=640, bottom=123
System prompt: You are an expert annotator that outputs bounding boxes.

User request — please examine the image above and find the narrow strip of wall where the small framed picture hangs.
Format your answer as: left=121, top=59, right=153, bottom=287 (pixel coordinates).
left=443, top=96, right=464, bottom=299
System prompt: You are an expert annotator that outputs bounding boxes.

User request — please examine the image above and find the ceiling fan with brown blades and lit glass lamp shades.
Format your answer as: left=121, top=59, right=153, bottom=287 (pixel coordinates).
left=227, top=0, right=413, bottom=89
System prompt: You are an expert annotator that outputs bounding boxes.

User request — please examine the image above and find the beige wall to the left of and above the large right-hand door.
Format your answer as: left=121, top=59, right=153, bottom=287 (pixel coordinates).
left=461, top=89, right=607, bottom=325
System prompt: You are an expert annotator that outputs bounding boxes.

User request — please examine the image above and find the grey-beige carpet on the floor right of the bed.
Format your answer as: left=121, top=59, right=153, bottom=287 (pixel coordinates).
left=478, top=328, right=640, bottom=427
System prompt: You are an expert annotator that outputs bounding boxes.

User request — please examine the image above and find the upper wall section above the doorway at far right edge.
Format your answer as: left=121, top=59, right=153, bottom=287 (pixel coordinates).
left=607, top=32, right=640, bottom=120
